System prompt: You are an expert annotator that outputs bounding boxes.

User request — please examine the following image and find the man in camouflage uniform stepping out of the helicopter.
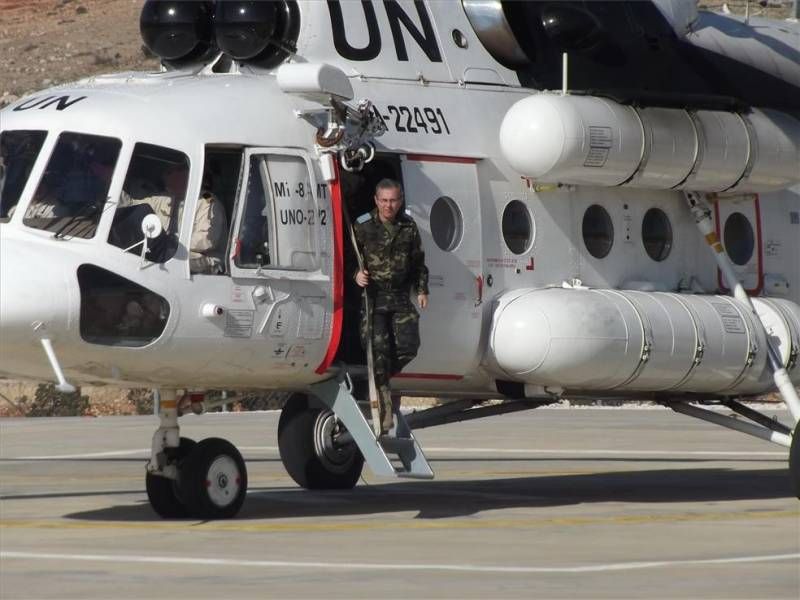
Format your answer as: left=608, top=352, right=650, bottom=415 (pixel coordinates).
left=355, top=179, right=428, bottom=433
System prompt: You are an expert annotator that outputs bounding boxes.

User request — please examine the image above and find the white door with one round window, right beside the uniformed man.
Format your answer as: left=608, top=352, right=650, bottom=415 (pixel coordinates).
left=400, top=155, right=483, bottom=379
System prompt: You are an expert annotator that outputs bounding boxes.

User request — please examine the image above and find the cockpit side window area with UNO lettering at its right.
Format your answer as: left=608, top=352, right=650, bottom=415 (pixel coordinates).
left=234, top=154, right=318, bottom=270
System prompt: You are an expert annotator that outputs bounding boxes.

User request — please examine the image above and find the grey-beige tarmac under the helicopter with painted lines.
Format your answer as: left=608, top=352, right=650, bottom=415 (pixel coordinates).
left=0, top=408, right=800, bottom=599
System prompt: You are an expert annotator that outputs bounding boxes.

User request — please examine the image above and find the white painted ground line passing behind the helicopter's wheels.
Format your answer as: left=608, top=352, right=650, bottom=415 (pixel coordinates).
left=0, top=446, right=788, bottom=460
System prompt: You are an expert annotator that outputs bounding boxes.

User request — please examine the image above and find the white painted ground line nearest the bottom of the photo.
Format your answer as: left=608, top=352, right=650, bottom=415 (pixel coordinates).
left=0, top=551, right=800, bottom=574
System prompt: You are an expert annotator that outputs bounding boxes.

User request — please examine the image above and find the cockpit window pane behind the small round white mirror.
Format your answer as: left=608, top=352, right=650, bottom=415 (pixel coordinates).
left=108, top=143, right=189, bottom=263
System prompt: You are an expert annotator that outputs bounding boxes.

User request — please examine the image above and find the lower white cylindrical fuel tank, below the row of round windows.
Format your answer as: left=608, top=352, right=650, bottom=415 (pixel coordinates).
left=487, top=288, right=800, bottom=394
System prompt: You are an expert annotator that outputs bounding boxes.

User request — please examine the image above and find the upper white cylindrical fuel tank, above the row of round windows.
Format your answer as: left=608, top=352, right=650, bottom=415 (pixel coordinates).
left=500, top=94, right=800, bottom=193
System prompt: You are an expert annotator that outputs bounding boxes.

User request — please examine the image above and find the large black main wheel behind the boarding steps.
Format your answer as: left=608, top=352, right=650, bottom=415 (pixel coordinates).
left=278, top=396, right=364, bottom=490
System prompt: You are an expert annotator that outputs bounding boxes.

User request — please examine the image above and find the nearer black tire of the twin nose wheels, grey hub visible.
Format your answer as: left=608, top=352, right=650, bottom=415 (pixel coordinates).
left=179, top=438, right=247, bottom=520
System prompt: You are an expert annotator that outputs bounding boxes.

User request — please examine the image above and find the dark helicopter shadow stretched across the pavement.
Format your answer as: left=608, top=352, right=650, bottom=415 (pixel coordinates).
left=65, top=468, right=794, bottom=521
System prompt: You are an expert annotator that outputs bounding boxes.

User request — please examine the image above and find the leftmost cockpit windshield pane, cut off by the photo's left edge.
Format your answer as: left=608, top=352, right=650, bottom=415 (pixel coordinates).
left=0, top=131, right=47, bottom=223
